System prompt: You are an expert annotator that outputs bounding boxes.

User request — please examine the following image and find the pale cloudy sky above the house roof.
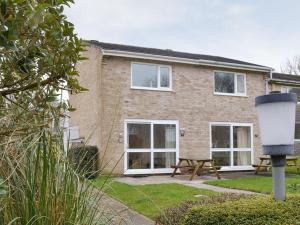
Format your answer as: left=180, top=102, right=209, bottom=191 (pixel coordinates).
left=65, top=0, right=300, bottom=71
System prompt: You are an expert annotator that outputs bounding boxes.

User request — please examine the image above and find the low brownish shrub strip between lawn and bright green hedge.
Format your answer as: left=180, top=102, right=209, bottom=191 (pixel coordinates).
left=155, top=193, right=247, bottom=225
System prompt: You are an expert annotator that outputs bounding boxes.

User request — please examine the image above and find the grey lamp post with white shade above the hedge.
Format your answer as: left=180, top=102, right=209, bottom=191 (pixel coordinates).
left=255, top=92, right=297, bottom=200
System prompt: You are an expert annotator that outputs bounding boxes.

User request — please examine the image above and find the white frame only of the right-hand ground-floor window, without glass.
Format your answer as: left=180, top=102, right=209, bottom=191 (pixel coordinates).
left=209, top=122, right=254, bottom=171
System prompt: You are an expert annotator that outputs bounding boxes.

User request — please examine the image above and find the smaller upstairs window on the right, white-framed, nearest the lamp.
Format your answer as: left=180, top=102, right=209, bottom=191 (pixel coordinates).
left=214, top=71, right=246, bottom=96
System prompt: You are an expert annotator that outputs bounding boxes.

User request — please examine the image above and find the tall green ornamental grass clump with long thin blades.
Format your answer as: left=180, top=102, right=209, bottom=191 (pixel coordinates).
left=0, top=130, right=106, bottom=225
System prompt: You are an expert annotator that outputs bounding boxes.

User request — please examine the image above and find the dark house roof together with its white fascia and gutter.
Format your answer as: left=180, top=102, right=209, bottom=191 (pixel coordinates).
left=88, top=40, right=272, bottom=72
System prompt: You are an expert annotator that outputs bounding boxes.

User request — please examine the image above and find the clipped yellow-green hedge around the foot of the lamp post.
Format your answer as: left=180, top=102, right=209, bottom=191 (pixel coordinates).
left=181, top=196, right=300, bottom=225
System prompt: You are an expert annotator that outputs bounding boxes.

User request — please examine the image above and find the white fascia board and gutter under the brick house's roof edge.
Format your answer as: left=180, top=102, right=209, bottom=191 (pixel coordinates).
left=102, top=49, right=272, bottom=72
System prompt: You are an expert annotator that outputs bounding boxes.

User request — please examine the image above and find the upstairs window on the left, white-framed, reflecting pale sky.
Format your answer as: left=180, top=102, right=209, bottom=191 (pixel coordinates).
left=131, top=63, right=172, bottom=91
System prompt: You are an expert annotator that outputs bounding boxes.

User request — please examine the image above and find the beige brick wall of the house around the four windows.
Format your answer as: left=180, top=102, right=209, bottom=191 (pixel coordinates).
left=71, top=44, right=265, bottom=173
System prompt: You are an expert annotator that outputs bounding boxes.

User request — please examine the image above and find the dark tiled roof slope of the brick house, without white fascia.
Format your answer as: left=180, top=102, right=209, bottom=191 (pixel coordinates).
left=88, top=40, right=271, bottom=70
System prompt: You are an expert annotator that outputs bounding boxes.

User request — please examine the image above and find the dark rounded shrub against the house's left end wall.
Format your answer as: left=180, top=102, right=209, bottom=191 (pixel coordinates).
left=69, top=144, right=98, bottom=179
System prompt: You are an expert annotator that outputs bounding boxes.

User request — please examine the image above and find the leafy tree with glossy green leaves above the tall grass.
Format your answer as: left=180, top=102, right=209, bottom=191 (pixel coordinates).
left=0, top=0, right=84, bottom=137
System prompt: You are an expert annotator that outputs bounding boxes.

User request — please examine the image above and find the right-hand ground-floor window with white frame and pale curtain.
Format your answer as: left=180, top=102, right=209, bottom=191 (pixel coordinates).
left=210, top=122, right=253, bottom=170
